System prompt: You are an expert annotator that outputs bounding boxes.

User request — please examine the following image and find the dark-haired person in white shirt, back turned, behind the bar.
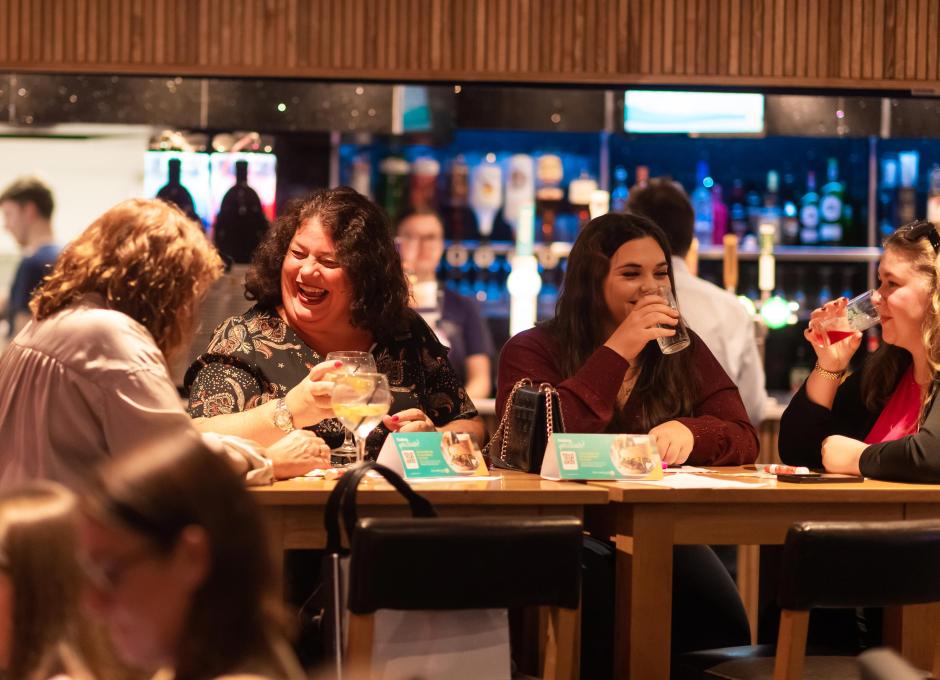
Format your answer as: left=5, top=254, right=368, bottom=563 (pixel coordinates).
left=627, top=178, right=767, bottom=427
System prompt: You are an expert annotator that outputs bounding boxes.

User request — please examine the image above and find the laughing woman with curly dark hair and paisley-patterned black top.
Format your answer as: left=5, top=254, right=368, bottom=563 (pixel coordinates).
left=186, top=187, right=483, bottom=456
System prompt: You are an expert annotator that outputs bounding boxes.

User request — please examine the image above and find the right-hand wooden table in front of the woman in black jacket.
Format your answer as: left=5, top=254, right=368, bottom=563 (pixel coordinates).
left=586, top=468, right=940, bottom=680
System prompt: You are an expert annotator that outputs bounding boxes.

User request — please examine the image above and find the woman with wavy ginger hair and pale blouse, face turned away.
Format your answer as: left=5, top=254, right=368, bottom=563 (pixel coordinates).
left=0, top=199, right=328, bottom=486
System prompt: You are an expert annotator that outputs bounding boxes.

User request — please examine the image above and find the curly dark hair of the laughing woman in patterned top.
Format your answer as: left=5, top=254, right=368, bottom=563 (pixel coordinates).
left=245, top=187, right=409, bottom=337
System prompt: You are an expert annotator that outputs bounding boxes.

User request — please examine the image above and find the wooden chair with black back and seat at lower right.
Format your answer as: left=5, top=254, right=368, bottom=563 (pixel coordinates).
left=677, top=520, right=940, bottom=680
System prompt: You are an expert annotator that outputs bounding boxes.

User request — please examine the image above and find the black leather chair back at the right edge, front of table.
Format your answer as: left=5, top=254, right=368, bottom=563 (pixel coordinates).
left=778, top=520, right=940, bottom=610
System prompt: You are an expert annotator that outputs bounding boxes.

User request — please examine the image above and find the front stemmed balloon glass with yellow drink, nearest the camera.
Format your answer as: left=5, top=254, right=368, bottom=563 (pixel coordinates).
left=332, top=372, right=392, bottom=463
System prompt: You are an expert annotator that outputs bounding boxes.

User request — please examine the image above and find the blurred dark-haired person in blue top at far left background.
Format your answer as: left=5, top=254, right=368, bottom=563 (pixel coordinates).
left=0, top=177, right=60, bottom=338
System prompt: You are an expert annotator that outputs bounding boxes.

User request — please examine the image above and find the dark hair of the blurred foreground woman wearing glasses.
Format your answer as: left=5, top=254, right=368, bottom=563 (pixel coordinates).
left=86, top=434, right=280, bottom=680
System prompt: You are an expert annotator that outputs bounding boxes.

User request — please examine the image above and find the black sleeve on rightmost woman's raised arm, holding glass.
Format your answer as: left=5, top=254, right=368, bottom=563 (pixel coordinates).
left=778, top=371, right=875, bottom=468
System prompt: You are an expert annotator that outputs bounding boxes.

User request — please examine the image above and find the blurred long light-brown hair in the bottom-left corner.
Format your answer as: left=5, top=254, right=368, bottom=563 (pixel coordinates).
left=0, top=482, right=116, bottom=680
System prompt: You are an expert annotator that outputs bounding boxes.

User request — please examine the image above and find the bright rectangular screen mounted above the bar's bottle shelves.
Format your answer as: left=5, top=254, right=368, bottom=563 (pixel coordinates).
left=623, top=90, right=764, bottom=134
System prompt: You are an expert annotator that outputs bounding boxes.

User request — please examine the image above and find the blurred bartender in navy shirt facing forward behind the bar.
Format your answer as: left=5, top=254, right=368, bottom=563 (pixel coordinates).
left=397, top=210, right=493, bottom=399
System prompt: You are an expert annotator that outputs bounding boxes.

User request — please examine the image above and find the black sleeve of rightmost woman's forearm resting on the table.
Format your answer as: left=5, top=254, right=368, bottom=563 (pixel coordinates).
left=858, top=388, right=940, bottom=483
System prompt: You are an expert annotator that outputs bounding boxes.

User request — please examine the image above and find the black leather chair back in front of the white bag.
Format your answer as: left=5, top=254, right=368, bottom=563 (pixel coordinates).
left=349, top=517, right=582, bottom=614
